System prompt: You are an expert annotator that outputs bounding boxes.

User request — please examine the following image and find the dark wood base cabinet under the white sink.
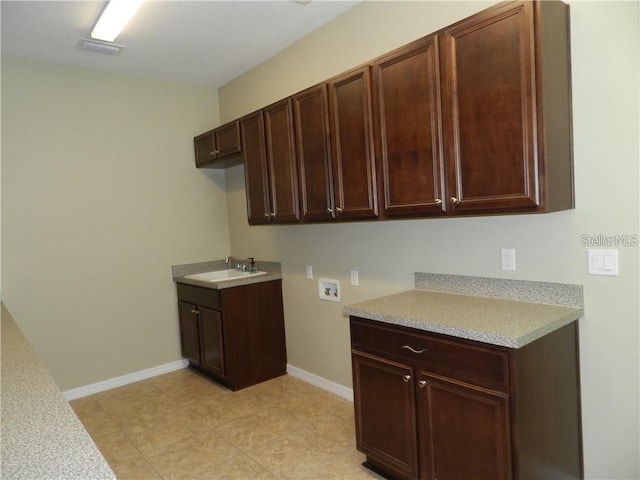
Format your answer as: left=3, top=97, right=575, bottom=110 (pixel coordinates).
left=177, top=280, right=287, bottom=390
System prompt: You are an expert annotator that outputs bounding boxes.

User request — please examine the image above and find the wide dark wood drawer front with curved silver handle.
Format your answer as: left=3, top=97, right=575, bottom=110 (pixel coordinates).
left=351, top=317, right=509, bottom=389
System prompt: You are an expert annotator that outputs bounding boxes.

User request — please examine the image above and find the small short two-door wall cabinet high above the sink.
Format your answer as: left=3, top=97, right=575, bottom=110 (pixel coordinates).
left=193, top=120, right=242, bottom=168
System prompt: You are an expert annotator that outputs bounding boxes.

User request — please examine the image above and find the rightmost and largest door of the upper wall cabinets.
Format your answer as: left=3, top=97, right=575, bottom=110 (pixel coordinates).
left=442, top=2, right=544, bottom=213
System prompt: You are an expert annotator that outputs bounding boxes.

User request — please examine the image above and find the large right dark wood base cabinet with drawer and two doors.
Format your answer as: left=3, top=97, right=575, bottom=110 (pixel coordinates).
left=351, top=317, right=583, bottom=480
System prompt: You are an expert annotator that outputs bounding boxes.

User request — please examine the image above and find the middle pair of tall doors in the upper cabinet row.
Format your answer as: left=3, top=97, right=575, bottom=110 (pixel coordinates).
left=293, top=66, right=378, bottom=221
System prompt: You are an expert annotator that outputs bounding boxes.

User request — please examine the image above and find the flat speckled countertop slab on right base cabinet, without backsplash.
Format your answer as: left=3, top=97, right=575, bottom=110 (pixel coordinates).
left=343, top=289, right=583, bottom=348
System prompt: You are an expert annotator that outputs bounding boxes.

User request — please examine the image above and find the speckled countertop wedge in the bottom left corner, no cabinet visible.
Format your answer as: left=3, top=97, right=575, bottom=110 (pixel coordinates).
left=0, top=305, right=116, bottom=480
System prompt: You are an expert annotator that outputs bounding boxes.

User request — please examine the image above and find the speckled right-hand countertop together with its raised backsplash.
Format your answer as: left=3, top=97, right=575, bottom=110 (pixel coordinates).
left=343, top=274, right=583, bottom=348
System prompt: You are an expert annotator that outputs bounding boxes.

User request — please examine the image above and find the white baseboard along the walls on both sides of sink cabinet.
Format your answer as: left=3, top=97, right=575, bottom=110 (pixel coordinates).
left=62, top=360, right=353, bottom=402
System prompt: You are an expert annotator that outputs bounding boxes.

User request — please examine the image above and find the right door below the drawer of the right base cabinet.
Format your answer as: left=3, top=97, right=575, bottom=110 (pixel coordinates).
left=418, top=372, right=511, bottom=480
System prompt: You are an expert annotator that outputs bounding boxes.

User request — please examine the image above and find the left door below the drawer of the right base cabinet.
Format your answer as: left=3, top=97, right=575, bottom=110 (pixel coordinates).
left=352, top=352, right=418, bottom=478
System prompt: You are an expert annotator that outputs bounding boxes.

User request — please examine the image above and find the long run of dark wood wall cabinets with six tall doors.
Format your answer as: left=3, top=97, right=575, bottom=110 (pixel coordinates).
left=212, top=0, right=574, bottom=224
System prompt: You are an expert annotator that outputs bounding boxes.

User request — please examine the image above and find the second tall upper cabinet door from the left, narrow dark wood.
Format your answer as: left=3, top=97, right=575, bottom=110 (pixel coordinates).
left=263, top=98, right=300, bottom=223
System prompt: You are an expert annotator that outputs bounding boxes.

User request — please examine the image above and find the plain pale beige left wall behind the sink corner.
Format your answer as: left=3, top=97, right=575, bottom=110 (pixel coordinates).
left=2, top=58, right=229, bottom=390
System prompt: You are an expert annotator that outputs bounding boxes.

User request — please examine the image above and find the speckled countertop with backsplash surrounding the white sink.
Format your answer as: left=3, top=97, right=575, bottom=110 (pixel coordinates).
left=171, top=257, right=282, bottom=290
